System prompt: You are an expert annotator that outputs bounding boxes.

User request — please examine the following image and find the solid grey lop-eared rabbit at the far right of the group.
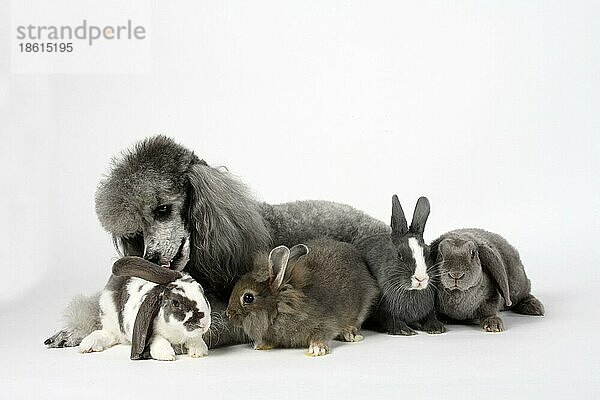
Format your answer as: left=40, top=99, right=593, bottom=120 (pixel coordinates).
left=431, top=229, right=544, bottom=332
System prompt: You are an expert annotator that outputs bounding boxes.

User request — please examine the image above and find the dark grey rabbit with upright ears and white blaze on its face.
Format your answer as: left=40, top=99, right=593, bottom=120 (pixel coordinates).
left=356, top=195, right=446, bottom=336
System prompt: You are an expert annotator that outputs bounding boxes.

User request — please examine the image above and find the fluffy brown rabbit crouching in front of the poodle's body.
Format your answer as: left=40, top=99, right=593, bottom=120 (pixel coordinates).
left=227, top=239, right=379, bottom=356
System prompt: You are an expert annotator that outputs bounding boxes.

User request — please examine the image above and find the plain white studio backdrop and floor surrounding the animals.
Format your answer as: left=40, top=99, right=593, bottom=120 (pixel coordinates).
left=0, top=0, right=600, bottom=398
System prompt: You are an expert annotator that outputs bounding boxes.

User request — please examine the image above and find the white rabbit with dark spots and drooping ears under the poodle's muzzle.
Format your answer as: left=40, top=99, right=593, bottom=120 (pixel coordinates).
left=79, top=257, right=211, bottom=361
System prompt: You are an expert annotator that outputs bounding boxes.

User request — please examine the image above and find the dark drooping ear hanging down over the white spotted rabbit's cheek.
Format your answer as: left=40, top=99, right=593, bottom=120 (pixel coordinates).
left=129, top=286, right=164, bottom=360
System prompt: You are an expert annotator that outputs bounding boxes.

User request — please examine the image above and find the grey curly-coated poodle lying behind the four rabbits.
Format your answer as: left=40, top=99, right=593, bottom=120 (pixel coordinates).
left=46, top=136, right=389, bottom=347
